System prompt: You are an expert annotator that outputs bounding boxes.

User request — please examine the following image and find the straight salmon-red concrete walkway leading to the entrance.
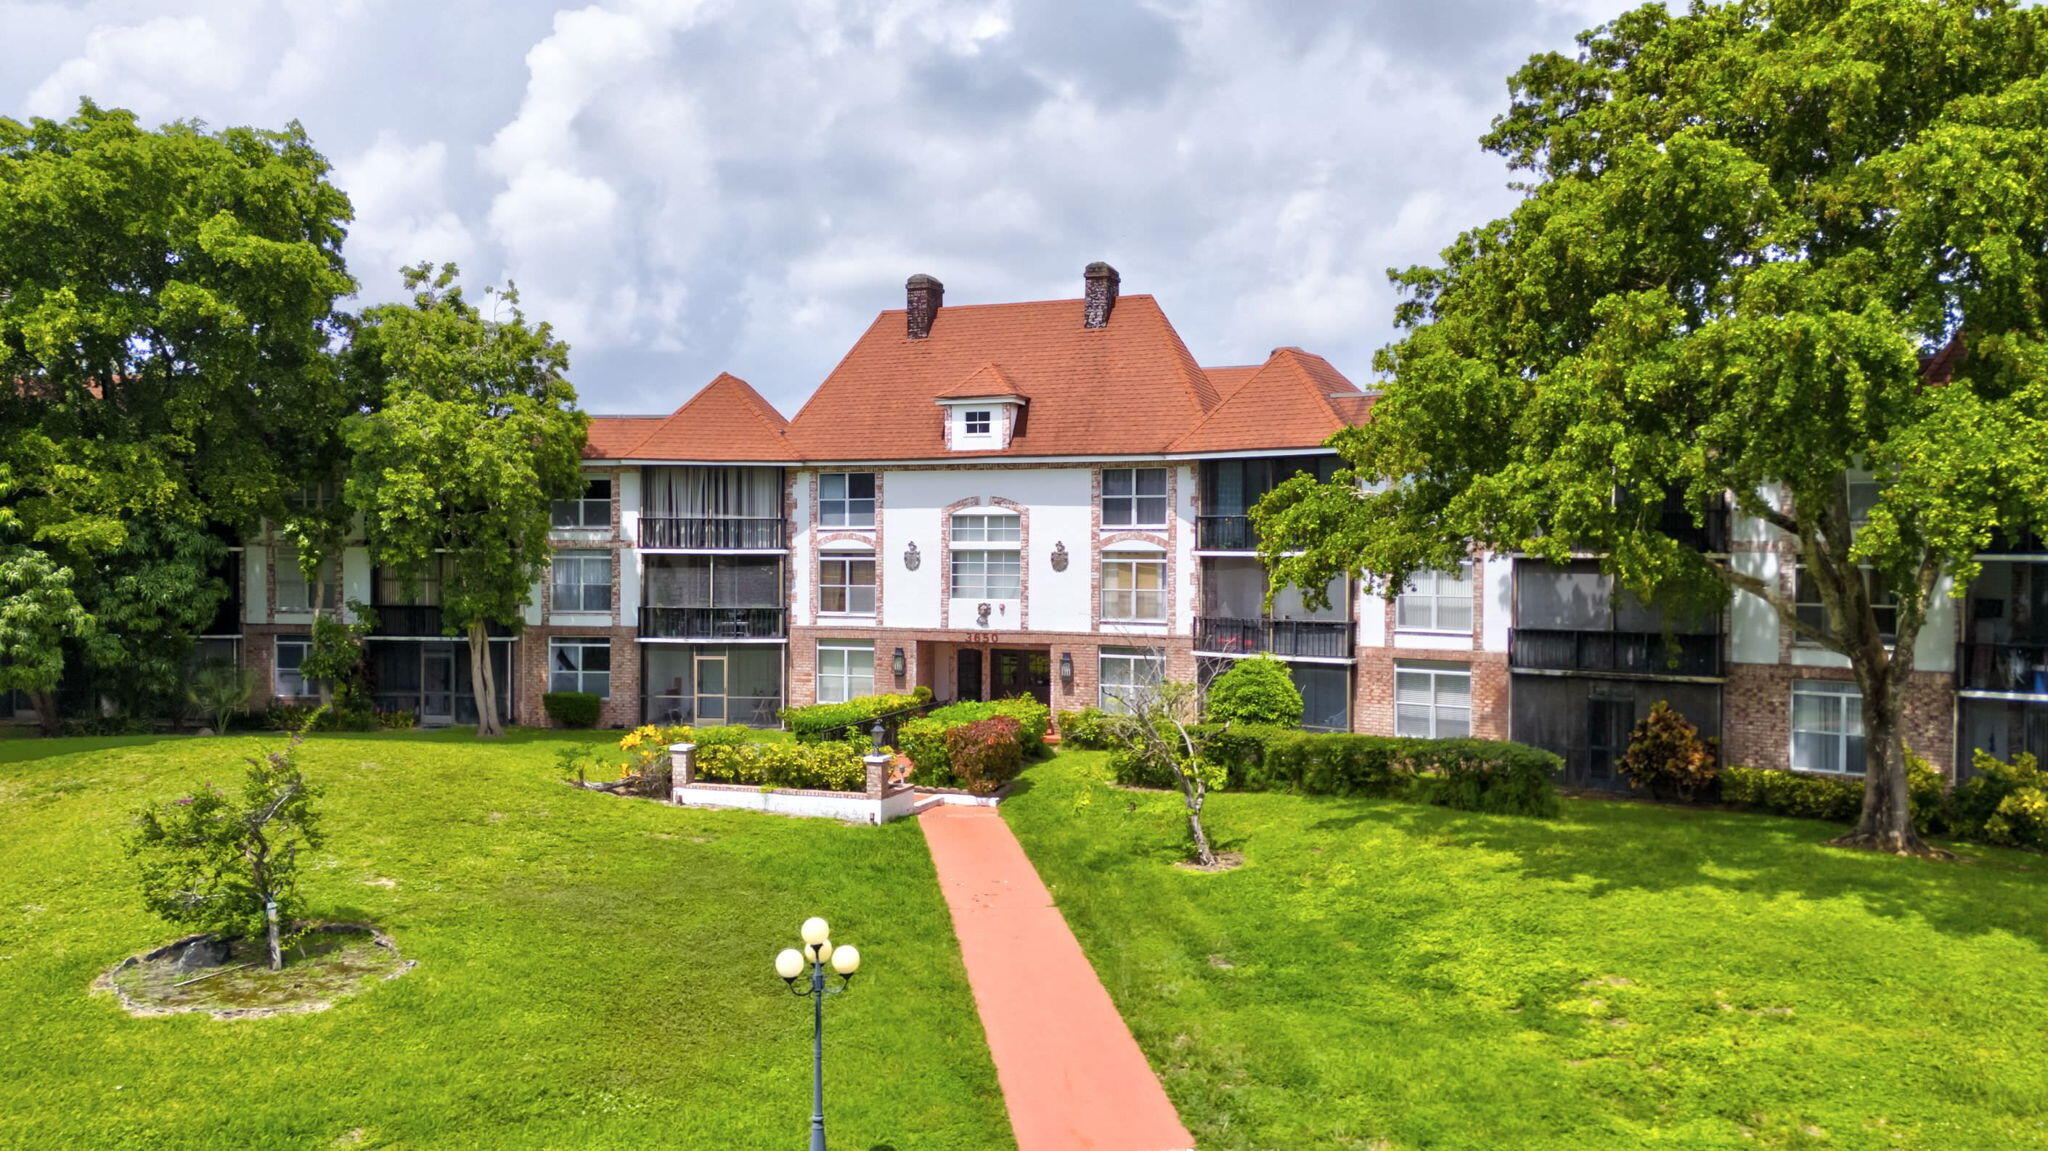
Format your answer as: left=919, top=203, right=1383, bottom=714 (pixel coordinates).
left=918, top=807, right=1194, bottom=1151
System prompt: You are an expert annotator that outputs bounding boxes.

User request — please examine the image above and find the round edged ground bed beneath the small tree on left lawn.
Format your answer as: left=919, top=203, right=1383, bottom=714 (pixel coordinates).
left=92, top=924, right=418, bottom=1020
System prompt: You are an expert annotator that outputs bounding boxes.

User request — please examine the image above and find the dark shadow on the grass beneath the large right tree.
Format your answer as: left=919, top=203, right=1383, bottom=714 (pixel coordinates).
left=1290, top=797, right=2048, bottom=950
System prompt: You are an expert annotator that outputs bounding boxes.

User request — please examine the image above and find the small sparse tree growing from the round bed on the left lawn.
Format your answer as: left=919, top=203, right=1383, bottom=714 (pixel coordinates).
left=129, top=711, right=322, bottom=971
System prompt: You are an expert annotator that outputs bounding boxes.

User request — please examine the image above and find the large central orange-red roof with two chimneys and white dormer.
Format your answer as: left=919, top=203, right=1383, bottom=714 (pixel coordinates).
left=788, top=295, right=1217, bottom=461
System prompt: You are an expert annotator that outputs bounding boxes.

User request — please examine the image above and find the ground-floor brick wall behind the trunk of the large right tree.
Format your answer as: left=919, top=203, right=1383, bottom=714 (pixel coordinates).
left=1720, top=664, right=1956, bottom=772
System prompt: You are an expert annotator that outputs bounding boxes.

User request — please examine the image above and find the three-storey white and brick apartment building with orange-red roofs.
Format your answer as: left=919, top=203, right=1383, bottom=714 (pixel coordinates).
left=151, top=264, right=2048, bottom=786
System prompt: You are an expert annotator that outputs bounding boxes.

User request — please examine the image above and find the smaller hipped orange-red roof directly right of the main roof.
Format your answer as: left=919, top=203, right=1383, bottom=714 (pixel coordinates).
left=1174, top=348, right=1372, bottom=453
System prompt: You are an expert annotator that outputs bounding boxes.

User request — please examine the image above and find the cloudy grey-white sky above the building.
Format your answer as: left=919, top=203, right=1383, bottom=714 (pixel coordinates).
left=0, top=0, right=1626, bottom=412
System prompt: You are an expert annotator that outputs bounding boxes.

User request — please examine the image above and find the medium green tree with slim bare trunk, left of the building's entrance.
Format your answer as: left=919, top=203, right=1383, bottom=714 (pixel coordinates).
left=344, top=264, right=590, bottom=735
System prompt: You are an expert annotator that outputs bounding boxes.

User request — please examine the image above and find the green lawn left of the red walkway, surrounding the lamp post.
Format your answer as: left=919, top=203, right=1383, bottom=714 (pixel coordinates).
left=0, top=731, right=1012, bottom=1151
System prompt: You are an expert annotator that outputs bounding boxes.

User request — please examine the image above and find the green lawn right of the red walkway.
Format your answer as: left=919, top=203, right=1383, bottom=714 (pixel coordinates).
left=1001, top=754, right=2048, bottom=1151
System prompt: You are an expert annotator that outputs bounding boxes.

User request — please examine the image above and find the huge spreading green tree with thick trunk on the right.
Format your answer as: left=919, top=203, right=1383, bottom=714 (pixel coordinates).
left=1257, top=0, right=2048, bottom=852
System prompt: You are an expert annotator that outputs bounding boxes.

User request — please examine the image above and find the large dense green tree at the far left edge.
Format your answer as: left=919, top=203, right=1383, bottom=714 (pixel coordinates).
left=0, top=102, right=354, bottom=702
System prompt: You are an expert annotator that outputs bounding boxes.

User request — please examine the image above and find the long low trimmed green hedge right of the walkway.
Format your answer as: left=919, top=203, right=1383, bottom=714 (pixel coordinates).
left=1110, top=723, right=1565, bottom=817
